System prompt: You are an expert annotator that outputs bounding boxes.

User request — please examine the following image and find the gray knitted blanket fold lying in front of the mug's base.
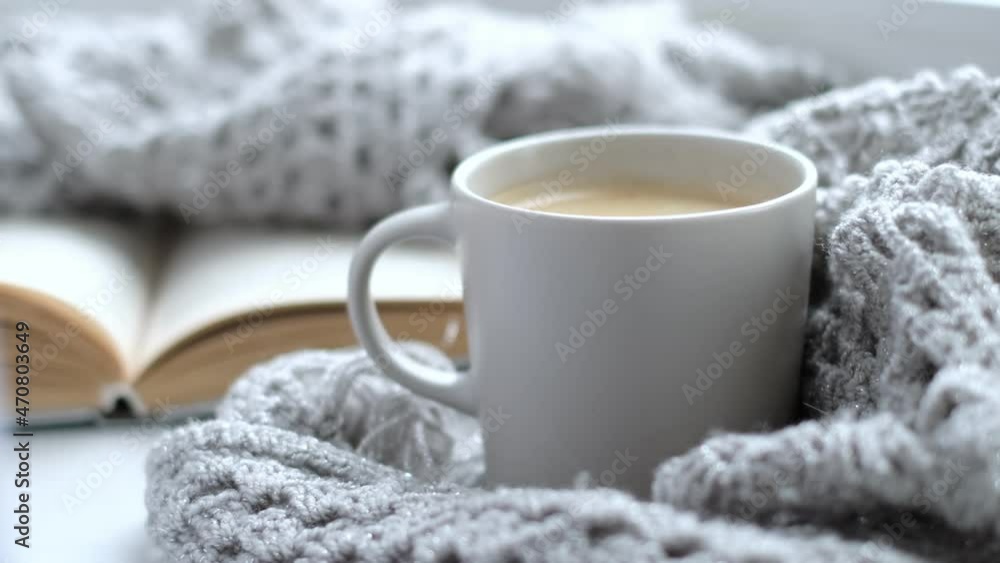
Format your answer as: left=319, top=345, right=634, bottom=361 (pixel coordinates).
left=146, top=349, right=924, bottom=563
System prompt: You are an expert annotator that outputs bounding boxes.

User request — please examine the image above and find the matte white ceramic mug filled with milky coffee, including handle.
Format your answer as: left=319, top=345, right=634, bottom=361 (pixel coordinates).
left=349, top=127, right=816, bottom=496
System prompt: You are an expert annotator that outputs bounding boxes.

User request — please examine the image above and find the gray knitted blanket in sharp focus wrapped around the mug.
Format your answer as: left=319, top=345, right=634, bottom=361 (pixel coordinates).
left=147, top=69, right=1000, bottom=563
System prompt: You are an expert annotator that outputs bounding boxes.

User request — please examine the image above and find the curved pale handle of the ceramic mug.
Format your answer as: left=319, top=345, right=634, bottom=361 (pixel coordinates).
left=347, top=202, right=479, bottom=415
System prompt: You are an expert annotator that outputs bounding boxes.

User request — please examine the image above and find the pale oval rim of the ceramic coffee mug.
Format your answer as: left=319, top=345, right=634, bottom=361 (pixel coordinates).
left=451, top=125, right=818, bottom=223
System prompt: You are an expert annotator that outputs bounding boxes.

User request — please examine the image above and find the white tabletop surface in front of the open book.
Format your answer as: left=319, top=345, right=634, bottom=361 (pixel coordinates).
left=7, top=423, right=165, bottom=563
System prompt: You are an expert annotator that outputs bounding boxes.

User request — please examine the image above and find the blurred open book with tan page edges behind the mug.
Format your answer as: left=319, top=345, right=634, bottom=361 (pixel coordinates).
left=0, top=219, right=466, bottom=422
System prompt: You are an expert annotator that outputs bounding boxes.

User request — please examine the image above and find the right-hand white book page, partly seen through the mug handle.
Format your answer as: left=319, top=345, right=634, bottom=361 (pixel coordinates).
left=136, top=228, right=462, bottom=372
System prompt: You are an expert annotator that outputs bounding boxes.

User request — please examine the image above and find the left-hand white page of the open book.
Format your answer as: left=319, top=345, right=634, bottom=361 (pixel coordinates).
left=0, top=218, right=155, bottom=372
